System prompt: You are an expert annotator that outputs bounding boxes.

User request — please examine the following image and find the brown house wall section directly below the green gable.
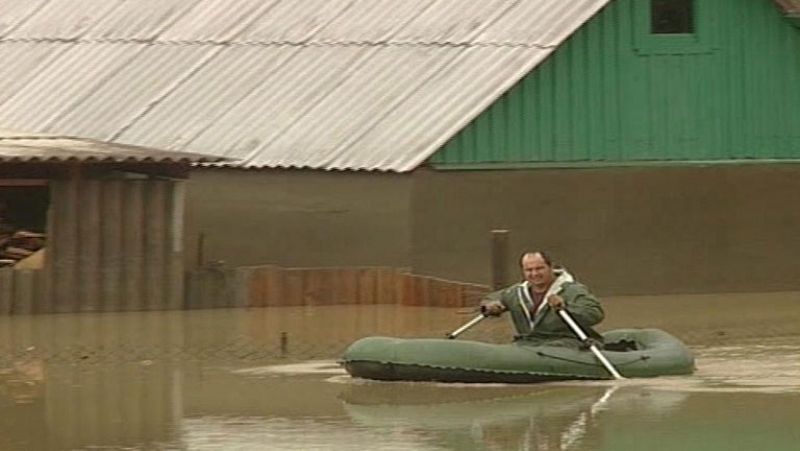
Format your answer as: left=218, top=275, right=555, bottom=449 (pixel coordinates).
left=411, top=165, right=800, bottom=294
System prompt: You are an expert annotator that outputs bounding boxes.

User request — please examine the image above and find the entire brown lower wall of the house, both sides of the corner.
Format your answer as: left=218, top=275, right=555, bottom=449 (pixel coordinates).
left=185, top=165, right=800, bottom=295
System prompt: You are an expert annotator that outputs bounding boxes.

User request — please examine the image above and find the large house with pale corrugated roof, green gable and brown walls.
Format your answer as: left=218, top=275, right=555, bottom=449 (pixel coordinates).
left=0, top=0, right=800, bottom=294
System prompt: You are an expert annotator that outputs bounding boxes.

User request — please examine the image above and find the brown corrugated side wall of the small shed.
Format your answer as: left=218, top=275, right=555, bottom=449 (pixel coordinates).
left=45, top=178, right=184, bottom=312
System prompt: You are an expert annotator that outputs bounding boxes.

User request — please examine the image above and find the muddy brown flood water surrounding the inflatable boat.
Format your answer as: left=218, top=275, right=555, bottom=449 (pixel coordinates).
left=0, top=293, right=800, bottom=451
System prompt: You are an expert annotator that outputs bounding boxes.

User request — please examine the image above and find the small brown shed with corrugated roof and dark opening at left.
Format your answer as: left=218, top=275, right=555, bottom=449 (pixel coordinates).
left=0, top=131, right=225, bottom=314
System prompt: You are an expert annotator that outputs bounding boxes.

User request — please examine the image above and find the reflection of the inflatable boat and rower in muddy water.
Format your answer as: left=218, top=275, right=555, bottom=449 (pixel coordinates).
left=341, top=383, right=686, bottom=451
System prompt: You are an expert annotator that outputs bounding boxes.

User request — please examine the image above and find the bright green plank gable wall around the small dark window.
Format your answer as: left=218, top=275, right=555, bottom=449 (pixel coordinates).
left=430, top=0, right=800, bottom=168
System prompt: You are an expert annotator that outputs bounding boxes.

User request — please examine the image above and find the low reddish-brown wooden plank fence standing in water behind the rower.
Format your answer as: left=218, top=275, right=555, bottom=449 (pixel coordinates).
left=186, top=266, right=489, bottom=308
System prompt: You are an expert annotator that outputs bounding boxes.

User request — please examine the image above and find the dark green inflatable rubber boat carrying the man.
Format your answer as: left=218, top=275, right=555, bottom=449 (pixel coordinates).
left=342, top=329, right=694, bottom=383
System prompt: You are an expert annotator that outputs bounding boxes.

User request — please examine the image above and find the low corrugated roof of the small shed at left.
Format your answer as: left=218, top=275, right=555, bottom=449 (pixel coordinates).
left=0, top=130, right=226, bottom=163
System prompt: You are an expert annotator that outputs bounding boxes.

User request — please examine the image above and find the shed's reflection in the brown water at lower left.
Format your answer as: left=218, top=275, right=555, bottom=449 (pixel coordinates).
left=0, top=314, right=183, bottom=450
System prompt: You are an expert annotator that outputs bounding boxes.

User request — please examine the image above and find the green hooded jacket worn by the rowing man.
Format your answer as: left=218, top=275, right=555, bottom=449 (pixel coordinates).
left=486, top=269, right=605, bottom=345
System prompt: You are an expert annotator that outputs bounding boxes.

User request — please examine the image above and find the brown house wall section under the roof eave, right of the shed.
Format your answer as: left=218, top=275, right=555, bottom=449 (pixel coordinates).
left=185, top=169, right=411, bottom=267
